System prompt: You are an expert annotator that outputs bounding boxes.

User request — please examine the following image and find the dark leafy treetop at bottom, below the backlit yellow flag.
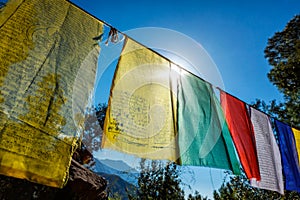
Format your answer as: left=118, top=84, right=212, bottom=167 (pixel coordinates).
left=128, top=159, right=184, bottom=200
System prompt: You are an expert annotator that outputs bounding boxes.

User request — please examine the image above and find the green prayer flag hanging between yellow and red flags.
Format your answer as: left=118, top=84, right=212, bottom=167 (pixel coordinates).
left=177, top=72, right=240, bottom=174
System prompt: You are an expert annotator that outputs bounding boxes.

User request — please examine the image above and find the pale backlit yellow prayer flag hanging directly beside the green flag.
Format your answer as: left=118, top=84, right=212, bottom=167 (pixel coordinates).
left=102, top=38, right=178, bottom=161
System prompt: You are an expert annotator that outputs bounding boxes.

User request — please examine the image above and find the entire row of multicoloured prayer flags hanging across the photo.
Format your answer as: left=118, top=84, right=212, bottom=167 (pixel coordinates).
left=0, top=0, right=300, bottom=194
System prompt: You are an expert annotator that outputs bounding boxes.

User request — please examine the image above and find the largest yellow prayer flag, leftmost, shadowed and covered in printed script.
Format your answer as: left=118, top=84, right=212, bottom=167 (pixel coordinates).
left=0, top=0, right=102, bottom=187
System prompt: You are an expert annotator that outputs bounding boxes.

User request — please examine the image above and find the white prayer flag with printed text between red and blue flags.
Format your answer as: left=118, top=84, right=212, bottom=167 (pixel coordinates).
left=250, top=107, right=284, bottom=194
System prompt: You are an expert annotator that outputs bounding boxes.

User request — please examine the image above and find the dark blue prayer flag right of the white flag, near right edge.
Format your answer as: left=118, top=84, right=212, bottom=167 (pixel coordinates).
left=275, top=119, right=300, bottom=192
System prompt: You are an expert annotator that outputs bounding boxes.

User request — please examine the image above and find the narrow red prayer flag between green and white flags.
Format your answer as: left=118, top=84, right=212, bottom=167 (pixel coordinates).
left=220, top=90, right=261, bottom=181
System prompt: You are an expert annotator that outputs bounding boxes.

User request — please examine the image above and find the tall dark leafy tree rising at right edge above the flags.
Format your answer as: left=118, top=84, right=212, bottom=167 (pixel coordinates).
left=264, top=15, right=300, bottom=128
